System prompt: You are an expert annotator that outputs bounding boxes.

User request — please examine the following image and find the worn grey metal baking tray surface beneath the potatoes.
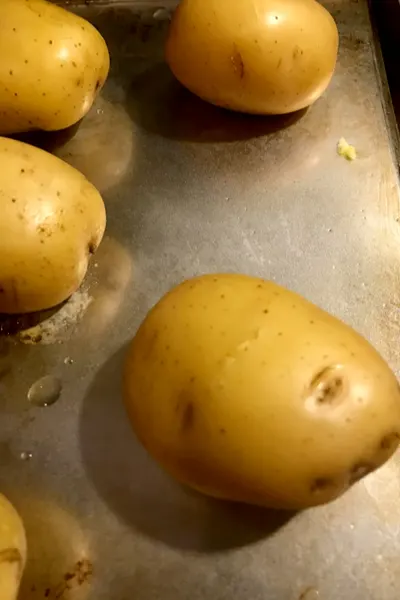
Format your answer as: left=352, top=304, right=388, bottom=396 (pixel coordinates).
left=0, top=0, right=400, bottom=600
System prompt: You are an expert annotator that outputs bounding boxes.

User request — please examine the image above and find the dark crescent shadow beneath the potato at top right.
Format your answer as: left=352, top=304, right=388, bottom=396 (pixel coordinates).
left=127, top=63, right=307, bottom=143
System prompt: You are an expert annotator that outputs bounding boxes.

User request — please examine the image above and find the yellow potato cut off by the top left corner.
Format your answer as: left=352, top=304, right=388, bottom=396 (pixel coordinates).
left=0, top=0, right=110, bottom=135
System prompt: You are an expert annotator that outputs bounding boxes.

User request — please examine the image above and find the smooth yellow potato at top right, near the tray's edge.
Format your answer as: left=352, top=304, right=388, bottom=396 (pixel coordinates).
left=166, top=0, right=338, bottom=114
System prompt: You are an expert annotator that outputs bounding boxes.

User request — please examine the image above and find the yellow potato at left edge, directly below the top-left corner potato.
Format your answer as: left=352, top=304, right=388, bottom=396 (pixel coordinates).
left=0, top=138, right=106, bottom=313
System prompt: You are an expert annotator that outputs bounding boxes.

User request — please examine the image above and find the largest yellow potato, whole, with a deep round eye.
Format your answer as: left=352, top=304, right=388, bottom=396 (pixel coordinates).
left=125, top=274, right=400, bottom=509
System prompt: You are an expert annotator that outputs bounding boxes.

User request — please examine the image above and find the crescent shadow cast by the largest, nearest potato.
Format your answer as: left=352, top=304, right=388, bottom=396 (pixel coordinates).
left=79, top=348, right=293, bottom=552
